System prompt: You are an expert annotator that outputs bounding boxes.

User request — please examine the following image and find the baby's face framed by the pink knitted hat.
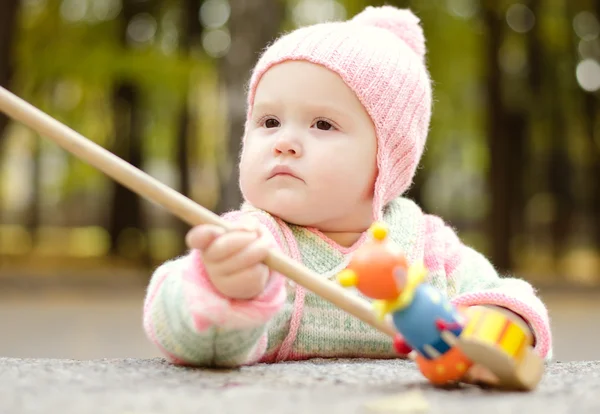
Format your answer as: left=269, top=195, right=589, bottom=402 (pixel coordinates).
left=240, top=61, right=377, bottom=232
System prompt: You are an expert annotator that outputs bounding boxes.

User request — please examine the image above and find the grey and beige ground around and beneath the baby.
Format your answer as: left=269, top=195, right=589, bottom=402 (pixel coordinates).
left=0, top=280, right=600, bottom=414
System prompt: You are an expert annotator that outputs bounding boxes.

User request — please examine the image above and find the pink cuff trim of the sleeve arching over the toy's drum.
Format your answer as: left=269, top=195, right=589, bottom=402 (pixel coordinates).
left=452, top=291, right=552, bottom=358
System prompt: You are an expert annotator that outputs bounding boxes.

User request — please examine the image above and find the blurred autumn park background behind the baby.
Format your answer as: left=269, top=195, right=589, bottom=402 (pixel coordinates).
left=0, top=0, right=600, bottom=360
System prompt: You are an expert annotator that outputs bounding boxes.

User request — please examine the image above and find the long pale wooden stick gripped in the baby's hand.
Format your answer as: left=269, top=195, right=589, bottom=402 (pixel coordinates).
left=0, top=87, right=396, bottom=337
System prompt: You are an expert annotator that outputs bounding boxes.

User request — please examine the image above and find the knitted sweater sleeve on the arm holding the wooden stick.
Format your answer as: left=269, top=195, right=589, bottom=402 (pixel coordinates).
left=143, top=212, right=286, bottom=367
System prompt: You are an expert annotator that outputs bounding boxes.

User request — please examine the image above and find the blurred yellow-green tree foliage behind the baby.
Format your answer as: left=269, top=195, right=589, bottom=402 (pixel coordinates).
left=0, top=0, right=600, bottom=282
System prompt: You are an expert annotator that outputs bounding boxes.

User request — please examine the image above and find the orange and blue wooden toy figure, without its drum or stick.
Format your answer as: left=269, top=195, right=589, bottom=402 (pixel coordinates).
left=338, top=223, right=472, bottom=384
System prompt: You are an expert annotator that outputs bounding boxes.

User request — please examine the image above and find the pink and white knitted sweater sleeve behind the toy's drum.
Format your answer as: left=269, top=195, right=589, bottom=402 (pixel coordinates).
left=425, top=215, right=552, bottom=360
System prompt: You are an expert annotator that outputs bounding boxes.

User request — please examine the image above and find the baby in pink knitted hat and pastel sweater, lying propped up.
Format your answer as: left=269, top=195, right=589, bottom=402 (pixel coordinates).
left=143, top=6, right=552, bottom=367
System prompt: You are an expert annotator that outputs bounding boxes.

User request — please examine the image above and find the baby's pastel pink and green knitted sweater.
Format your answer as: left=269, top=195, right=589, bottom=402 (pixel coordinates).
left=143, top=197, right=552, bottom=367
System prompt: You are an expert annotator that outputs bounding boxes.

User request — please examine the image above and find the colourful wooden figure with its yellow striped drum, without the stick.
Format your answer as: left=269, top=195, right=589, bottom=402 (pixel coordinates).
left=338, top=223, right=543, bottom=390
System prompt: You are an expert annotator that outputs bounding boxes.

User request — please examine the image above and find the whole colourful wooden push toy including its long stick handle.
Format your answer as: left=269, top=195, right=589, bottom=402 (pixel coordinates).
left=0, top=87, right=543, bottom=389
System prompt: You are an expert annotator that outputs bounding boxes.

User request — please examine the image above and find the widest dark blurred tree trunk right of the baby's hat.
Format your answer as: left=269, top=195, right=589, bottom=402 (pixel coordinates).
left=483, top=0, right=538, bottom=272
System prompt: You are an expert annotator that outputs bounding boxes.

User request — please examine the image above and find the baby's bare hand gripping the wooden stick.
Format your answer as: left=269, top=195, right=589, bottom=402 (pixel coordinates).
left=186, top=223, right=273, bottom=299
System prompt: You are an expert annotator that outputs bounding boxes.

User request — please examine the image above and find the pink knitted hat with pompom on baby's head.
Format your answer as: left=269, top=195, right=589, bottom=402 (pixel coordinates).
left=247, top=6, right=432, bottom=220
